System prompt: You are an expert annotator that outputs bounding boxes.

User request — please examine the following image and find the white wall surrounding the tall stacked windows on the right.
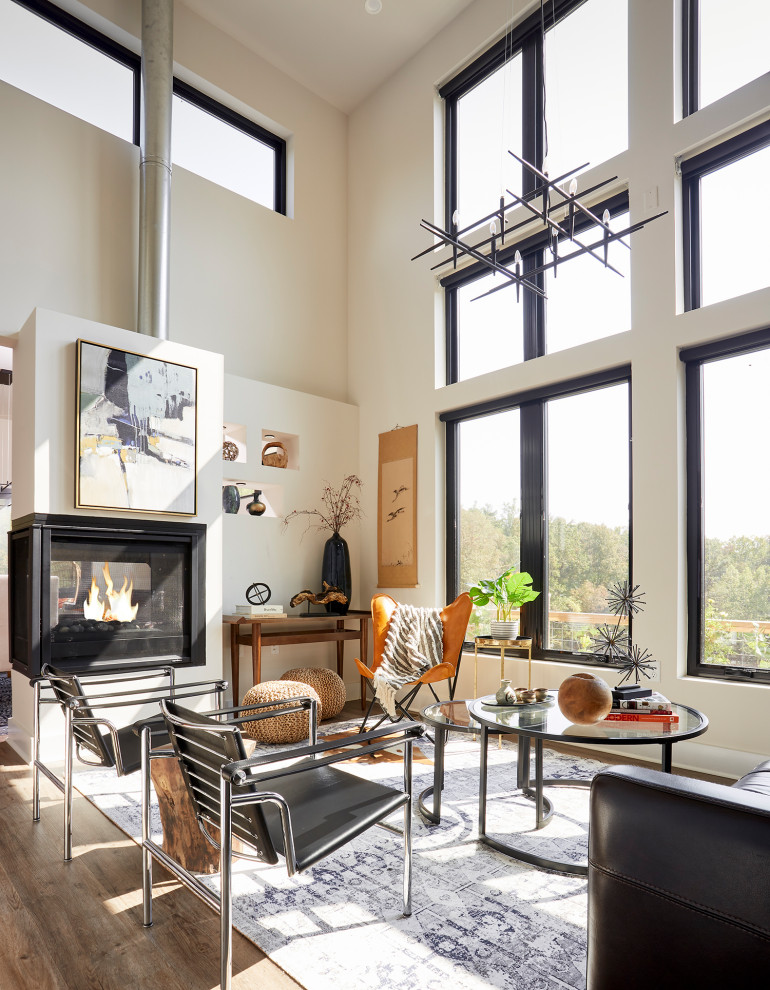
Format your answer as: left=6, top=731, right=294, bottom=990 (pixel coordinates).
left=348, top=0, right=770, bottom=773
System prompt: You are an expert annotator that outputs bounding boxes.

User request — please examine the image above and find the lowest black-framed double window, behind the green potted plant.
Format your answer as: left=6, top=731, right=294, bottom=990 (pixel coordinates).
left=441, top=366, right=631, bottom=661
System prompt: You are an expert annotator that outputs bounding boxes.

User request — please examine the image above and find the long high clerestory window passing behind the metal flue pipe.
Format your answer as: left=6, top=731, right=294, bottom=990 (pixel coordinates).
left=0, top=0, right=286, bottom=214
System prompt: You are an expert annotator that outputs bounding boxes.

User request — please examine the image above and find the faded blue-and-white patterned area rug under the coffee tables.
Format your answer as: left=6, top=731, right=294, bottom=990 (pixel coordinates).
left=75, top=724, right=602, bottom=990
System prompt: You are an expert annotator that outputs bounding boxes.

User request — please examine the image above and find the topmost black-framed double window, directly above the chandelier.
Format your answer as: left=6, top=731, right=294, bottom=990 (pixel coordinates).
left=439, top=0, right=628, bottom=234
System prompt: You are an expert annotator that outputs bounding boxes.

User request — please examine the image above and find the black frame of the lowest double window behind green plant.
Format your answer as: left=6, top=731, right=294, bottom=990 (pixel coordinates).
left=439, top=364, right=633, bottom=665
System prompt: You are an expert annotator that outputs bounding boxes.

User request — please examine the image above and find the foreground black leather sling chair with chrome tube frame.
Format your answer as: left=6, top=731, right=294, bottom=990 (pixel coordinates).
left=141, top=697, right=425, bottom=990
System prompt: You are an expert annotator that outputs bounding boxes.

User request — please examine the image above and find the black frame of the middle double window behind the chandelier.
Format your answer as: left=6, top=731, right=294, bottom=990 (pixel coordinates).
left=439, top=191, right=629, bottom=385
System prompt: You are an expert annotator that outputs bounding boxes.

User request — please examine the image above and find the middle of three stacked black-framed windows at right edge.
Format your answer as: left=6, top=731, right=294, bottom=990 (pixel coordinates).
left=681, top=121, right=770, bottom=310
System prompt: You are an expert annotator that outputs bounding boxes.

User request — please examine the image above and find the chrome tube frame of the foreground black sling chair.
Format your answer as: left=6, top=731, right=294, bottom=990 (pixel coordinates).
left=141, top=697, right=425, bottom=990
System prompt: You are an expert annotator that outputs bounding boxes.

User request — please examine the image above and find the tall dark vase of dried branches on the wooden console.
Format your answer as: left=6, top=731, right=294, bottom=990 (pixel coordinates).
left=283, top=474, right=362, bottom=615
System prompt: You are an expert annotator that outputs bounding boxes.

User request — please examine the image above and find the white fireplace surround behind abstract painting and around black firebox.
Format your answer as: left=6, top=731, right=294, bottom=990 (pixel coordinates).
left=8, top=309, right=224, bottom=760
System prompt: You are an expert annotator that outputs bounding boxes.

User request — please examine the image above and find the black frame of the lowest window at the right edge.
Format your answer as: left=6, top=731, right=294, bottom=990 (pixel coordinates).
left=679, top=327, right=770, bottom=683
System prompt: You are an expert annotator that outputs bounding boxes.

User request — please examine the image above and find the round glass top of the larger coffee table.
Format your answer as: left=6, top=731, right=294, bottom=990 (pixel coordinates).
left=464, top=691, right=708, bottom=745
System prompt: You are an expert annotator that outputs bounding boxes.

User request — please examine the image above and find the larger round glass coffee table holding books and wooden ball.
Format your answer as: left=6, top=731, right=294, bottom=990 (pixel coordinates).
left=468, top=691, right=708, bottom=876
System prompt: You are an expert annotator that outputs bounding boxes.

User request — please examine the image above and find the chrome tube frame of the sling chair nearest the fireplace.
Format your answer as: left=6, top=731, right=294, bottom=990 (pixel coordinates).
left=32, top=665, right=228, bottom=862
